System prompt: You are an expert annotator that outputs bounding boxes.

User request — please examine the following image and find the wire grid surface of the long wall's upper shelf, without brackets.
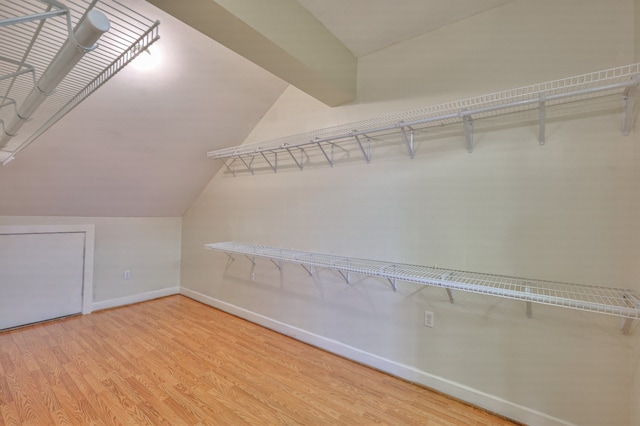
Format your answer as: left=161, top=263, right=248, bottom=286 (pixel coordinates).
left=207, top=63, right=640, bottom=163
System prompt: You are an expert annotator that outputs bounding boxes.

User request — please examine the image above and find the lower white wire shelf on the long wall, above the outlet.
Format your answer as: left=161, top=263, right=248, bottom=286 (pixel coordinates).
left=205, top=242, right=640, bottom=334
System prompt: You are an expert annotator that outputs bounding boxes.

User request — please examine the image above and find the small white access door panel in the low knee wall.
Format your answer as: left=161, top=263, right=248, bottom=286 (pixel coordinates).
left=0, top=232, right=85, bottom=330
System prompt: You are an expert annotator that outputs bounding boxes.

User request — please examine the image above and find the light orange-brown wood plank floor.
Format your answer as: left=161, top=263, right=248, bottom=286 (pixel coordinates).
left=0, top=296, right=514, bottom=426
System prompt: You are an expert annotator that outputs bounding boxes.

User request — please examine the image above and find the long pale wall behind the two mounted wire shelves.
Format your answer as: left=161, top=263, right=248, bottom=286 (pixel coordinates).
left=182, top=0, right=640, bottom=425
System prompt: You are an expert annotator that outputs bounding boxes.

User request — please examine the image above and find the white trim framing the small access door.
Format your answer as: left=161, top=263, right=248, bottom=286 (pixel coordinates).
left=0, top=224, right=96, bottom=315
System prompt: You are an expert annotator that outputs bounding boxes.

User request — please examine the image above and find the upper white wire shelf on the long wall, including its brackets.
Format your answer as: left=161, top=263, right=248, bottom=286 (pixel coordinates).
left=207, top=64, right=640, bottom=176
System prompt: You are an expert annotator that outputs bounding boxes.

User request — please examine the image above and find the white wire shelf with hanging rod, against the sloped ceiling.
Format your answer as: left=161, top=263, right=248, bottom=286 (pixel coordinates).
left=0, top=0, right=159, bottom=164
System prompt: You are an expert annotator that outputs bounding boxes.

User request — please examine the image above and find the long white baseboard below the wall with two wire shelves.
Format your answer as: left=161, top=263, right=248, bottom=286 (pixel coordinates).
left=180, top=287, right=575, bottom=426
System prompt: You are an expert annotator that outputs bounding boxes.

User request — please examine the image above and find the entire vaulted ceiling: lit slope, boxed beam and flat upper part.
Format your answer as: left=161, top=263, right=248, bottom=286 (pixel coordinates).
left=0, top=0, right=508, bottom=216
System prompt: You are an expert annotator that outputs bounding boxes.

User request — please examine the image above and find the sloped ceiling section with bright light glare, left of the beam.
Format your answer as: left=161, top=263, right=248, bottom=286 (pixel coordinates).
left=0, top=0, right=287, bottom=216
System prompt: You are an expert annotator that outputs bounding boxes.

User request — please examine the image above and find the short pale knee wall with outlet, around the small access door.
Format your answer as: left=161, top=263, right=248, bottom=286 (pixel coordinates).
left=0, top=216, right=182, bottom=309
